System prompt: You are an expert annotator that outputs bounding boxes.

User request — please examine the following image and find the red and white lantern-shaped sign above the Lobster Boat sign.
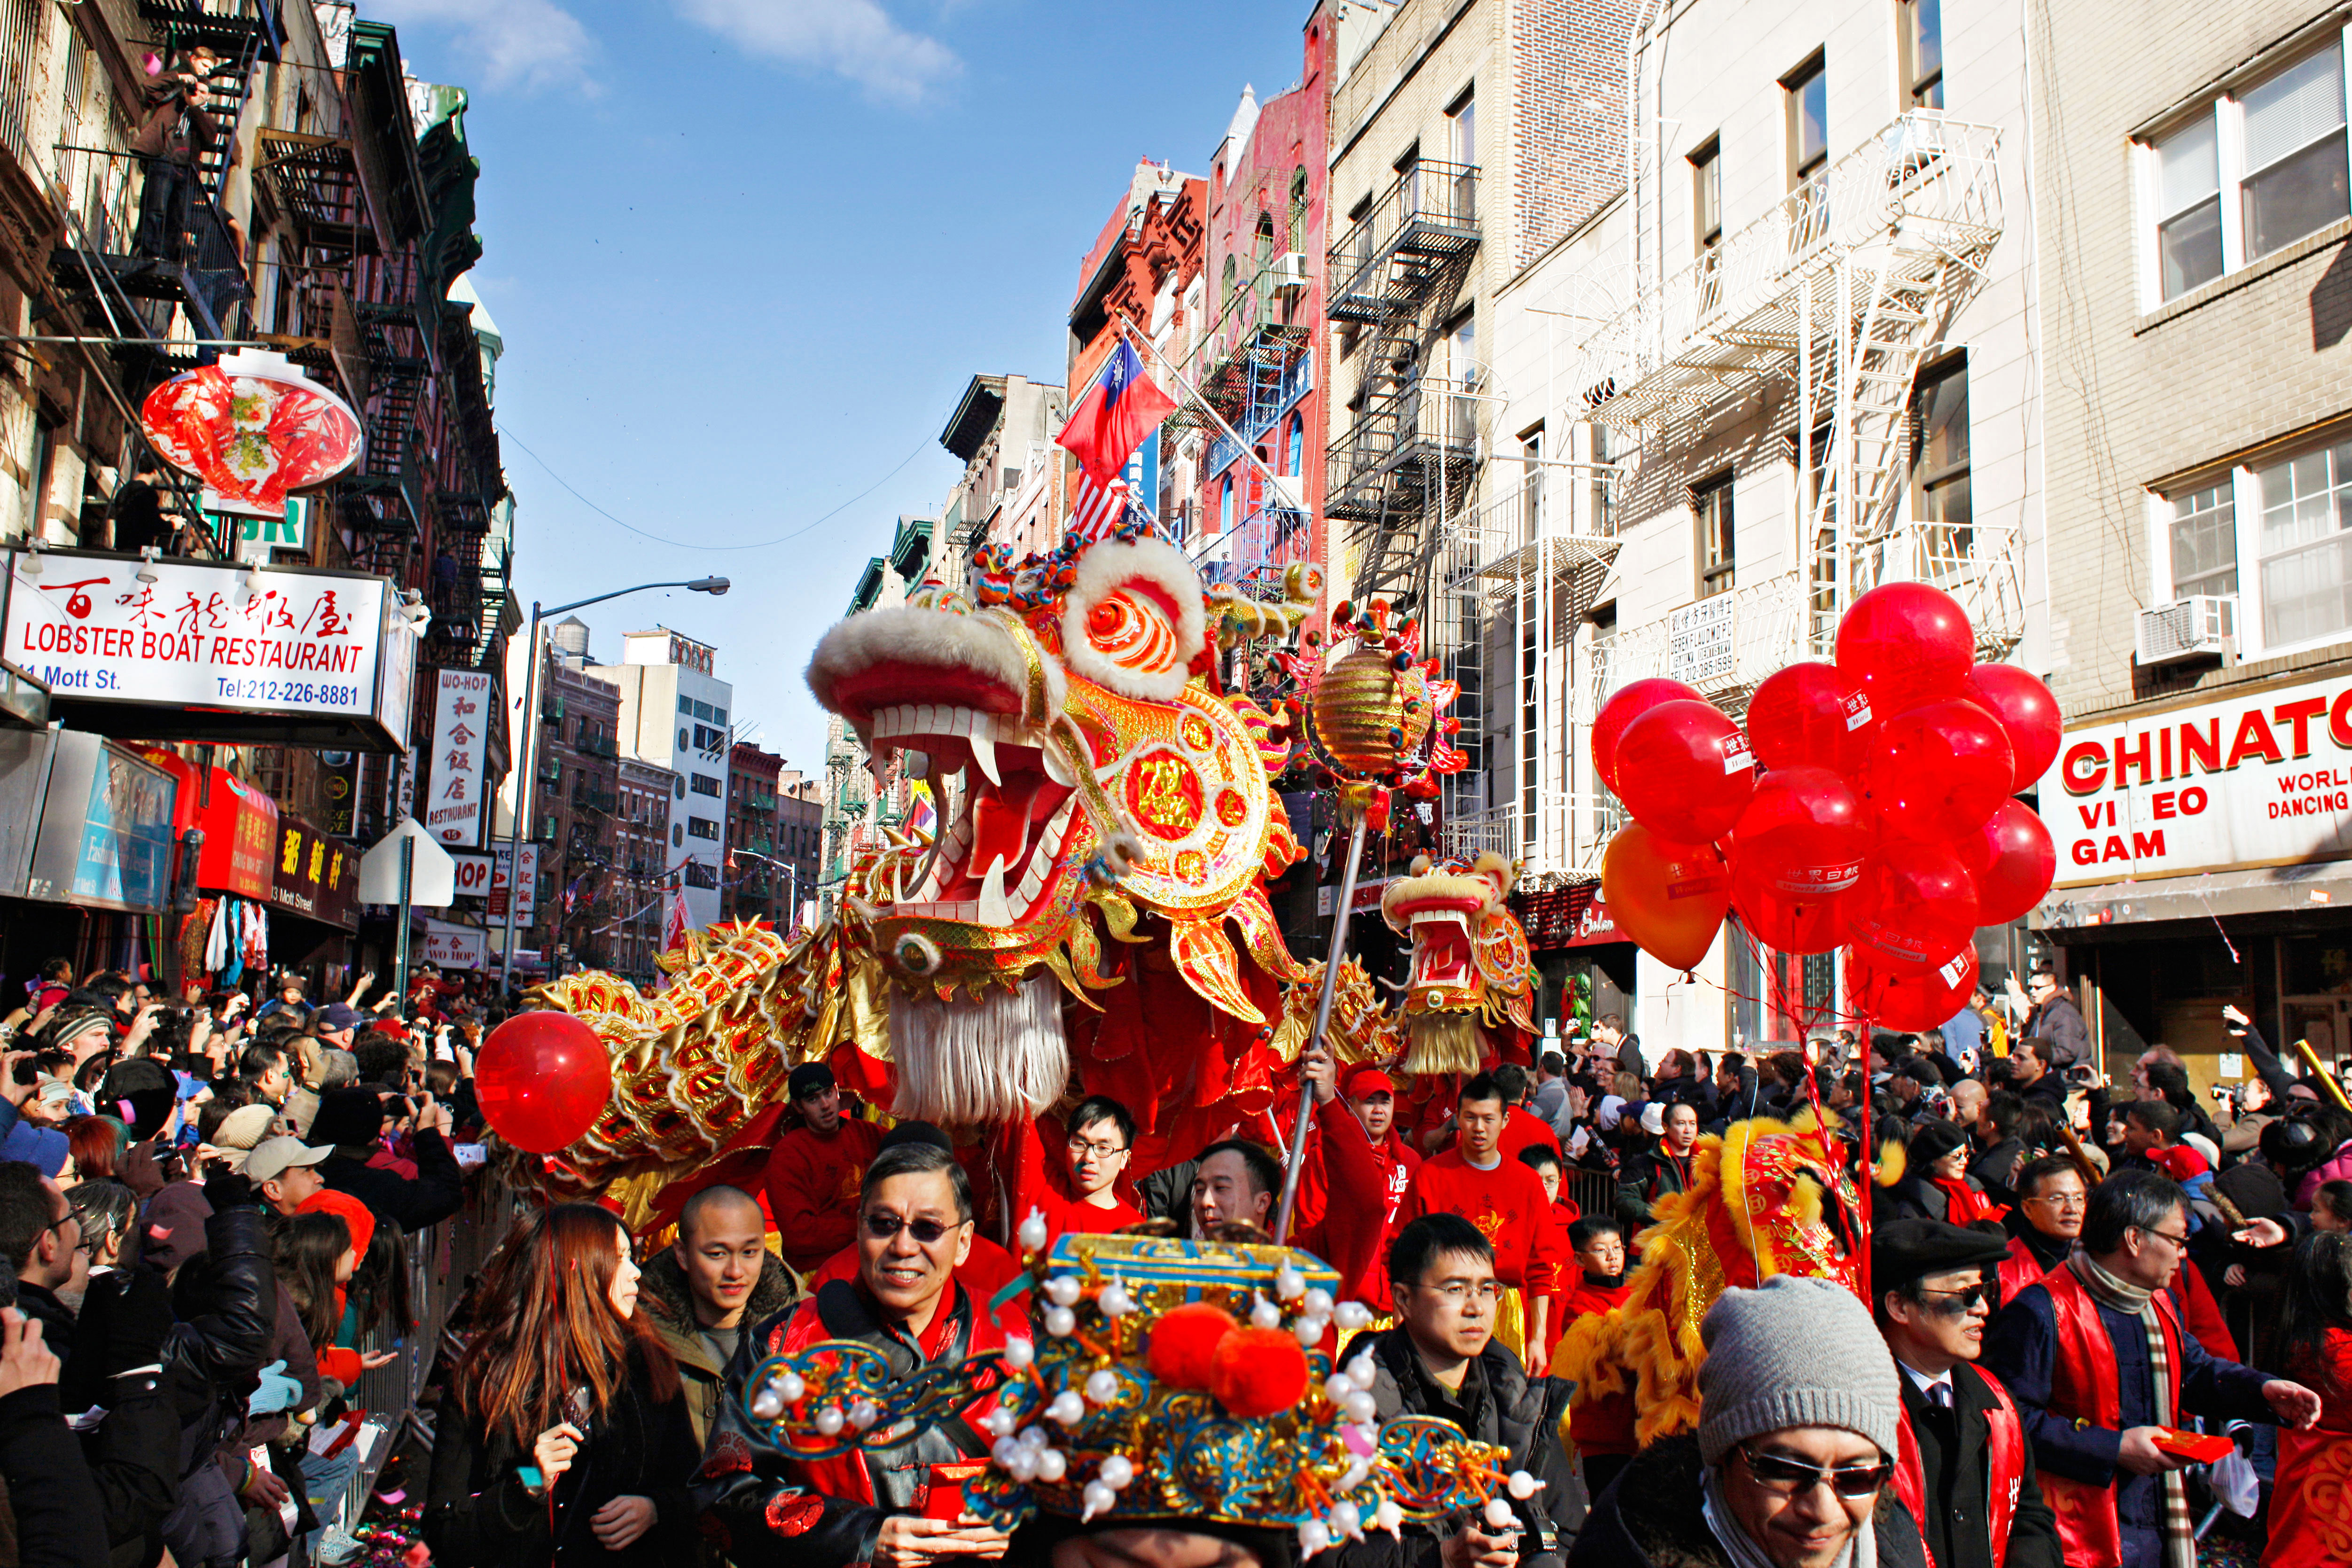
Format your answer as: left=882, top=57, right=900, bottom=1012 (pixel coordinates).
left=139, top=350, right=365, bottom=517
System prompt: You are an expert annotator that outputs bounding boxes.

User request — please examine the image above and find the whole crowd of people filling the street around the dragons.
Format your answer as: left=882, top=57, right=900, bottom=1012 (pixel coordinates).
left=0, top=959, right=2352, bottom=1568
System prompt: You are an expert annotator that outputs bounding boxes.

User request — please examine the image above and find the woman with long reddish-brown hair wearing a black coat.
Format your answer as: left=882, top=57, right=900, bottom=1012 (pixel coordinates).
left=423, top=1204, right=701, bottom=1568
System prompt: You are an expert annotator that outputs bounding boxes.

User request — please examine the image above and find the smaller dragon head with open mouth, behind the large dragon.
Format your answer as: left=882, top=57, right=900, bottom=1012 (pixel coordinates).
left=1381, top=851, right=1536, bottom=1072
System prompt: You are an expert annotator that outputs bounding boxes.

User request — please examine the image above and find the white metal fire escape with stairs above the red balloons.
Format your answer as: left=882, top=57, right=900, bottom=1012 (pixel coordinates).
left=1578, top=110, right=2025, bottom=719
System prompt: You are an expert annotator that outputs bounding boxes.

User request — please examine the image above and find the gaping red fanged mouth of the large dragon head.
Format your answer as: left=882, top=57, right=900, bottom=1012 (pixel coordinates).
left=868, top=703, right=1077, bottom=928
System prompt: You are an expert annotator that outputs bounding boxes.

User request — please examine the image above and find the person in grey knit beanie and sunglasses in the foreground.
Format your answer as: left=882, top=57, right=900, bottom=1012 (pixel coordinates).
left=1566, top=1274, right=1926, bottom=1568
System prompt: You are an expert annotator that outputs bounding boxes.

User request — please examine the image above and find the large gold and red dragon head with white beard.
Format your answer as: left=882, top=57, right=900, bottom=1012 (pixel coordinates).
left=807, top=538, right=1320, bottom=1126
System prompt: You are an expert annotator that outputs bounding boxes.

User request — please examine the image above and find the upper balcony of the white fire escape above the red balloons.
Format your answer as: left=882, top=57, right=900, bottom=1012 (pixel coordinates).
left=1573, top=110, right=2001, bottom=426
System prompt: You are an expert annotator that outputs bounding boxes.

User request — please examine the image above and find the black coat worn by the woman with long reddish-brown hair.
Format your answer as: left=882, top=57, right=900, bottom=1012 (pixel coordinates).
left=423, top=1347, right=701, bottom=1568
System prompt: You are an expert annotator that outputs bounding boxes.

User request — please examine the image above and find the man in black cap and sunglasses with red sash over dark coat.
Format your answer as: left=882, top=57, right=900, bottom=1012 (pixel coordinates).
left=1870, top=1220, right=2065, bottom=1568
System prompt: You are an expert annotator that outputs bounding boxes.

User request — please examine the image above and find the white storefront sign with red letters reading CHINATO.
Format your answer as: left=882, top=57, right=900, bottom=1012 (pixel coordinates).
left=2041, top=677, right=2352, bottom=889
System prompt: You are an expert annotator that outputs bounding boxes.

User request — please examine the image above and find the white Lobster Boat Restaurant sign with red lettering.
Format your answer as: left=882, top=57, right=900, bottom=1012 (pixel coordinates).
left=7, top=553, right=386, bottom=717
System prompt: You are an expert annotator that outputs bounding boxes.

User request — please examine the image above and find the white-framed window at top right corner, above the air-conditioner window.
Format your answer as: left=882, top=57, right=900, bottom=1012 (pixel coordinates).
left=2145, top=38, right=2352, bottom=303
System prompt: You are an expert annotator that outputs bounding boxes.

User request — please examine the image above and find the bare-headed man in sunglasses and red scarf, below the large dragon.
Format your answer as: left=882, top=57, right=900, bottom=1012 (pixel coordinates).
left=694, top=1142, right=1028, bottom=1568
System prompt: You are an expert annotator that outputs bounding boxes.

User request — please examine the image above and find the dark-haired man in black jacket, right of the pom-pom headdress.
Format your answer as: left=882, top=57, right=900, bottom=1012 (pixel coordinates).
left=1327, top=1213, right=1585, bottom=1568
